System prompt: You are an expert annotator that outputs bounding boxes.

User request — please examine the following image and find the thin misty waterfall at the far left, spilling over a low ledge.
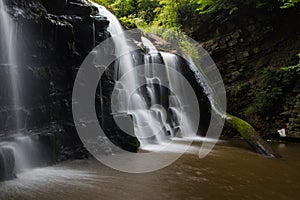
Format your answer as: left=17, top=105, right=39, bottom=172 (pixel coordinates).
left=0, top=0, right=44, bottom=180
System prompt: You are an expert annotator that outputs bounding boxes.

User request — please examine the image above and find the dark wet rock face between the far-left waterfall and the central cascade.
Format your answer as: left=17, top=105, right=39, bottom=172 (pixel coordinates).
left=0, top=0, right=139, bottom=180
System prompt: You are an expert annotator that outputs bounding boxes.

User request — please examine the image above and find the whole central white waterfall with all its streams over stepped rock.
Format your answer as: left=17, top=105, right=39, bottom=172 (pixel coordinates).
left=92, top=2, right=198, bottom=148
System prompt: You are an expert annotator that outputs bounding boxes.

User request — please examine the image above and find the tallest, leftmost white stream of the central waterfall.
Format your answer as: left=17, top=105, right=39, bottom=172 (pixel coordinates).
left=92, top=2, right=170, bottom=146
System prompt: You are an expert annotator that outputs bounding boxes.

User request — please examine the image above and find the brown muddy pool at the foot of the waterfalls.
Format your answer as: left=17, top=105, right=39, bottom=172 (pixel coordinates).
left=0, top=139, right=300, bottom=200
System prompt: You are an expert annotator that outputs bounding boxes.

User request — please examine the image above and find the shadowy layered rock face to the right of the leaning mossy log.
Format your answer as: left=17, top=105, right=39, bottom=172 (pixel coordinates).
left=193, top=6, right=300, bottom=137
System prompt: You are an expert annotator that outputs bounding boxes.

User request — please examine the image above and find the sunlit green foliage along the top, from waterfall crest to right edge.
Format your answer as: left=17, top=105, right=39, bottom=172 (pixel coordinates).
left=93, top=0, right=300, bottom=35
